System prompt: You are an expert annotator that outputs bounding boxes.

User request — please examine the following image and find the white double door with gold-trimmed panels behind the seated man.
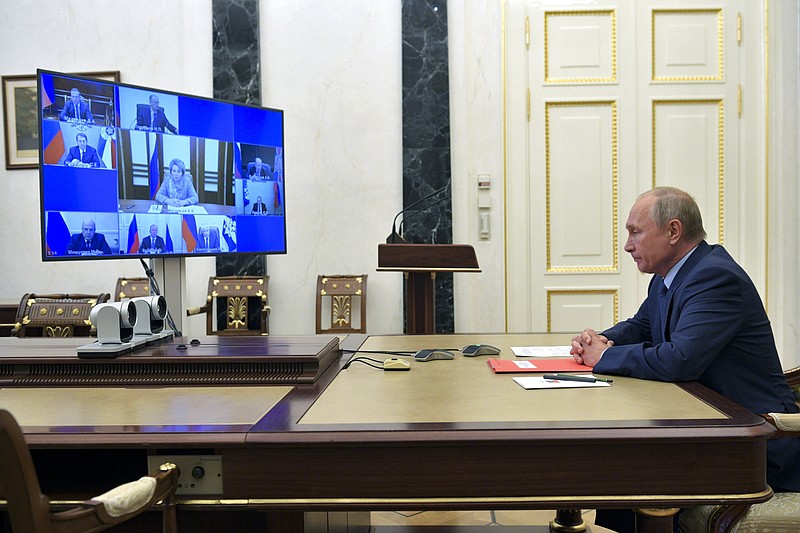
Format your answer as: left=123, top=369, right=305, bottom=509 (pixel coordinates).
left=505, top=0, right=766, bottom=332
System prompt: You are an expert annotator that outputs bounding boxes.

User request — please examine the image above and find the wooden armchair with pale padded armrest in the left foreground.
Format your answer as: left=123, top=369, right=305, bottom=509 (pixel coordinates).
left=0, top=409, right=178, bottom=533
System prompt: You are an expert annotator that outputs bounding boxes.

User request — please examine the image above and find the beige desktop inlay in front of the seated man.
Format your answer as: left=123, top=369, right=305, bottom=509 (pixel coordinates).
left=300, top=335, right=728, bottom=428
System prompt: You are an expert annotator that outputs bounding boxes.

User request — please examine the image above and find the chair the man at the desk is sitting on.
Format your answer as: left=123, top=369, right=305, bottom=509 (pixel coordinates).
left=678, top=367, right=800, bottom=533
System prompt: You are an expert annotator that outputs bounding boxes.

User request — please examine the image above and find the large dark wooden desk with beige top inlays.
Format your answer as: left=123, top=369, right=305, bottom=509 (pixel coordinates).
left=0, top=335, right=772, bottom=532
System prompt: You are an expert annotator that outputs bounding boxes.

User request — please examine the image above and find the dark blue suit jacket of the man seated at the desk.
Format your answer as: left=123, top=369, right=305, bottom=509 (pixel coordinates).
left=594, top=241, right=800, bottom=491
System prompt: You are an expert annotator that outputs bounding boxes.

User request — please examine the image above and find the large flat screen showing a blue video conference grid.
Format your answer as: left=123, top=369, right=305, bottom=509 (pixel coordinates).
left=37, top=70, right=286, bottom=261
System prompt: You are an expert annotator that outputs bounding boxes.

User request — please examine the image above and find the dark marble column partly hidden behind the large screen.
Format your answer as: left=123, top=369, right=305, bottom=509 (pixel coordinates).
left=211, top=0, right=267, bottom=276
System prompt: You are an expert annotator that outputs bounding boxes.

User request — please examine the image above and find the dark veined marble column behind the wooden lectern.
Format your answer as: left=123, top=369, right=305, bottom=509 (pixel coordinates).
left=402, top=0, right=455, bottom=333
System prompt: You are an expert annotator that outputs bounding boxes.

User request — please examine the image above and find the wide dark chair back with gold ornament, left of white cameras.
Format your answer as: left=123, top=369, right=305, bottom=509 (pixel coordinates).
left=12, top=292, right=111, bottom=337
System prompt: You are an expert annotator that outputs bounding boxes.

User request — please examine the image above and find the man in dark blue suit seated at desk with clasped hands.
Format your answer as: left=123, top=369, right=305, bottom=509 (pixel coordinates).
left=571, top=187, right=800, bottom=532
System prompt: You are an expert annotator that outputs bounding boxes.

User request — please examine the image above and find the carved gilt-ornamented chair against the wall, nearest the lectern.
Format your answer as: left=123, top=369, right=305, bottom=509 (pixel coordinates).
left=317, top=274, right=367, bottom=334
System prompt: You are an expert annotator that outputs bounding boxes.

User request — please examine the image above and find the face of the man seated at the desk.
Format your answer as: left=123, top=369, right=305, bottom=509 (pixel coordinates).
left=625, top=196, right=674, bottom=276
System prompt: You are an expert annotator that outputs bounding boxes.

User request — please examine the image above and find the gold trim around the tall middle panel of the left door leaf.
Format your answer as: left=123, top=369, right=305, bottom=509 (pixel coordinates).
left=544, top=100, right=619, bottom=274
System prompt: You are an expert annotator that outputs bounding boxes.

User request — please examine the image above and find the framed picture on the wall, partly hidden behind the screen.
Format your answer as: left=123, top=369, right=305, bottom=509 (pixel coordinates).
left=2, top=70, right=119, bottom=170
